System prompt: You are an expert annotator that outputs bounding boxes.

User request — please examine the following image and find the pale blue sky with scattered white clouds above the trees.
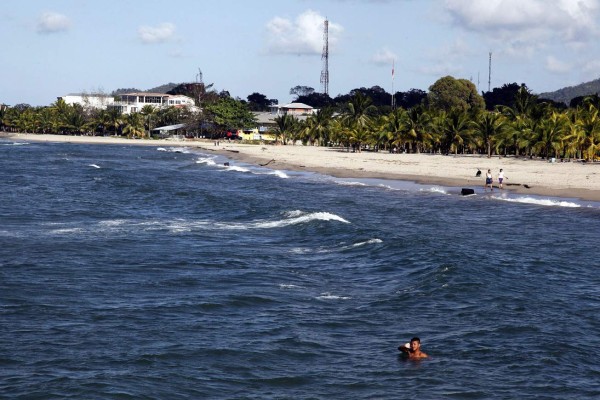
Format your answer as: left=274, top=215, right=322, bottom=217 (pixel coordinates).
left=0, top=0, right=600, bottom=106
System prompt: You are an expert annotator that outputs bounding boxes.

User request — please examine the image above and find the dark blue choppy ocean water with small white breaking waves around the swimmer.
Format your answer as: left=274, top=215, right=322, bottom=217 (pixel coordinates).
left=0, top=140, right=600, bottom=399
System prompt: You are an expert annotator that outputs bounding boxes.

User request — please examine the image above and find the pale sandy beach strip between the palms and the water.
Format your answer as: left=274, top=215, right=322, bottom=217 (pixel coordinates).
left=2, top=134, right=600, bottom=201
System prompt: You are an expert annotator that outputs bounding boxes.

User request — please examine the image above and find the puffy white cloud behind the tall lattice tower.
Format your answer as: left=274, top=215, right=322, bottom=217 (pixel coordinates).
left=266, top=10, right=343, bottom=55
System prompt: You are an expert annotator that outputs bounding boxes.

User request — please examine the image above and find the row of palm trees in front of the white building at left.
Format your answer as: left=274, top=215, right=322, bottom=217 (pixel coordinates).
left=0, top=99, right=189, bottom=138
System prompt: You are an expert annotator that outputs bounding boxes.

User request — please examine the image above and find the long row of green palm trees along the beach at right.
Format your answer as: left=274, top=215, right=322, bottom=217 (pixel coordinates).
left=275, top=88, right=600, bottom=160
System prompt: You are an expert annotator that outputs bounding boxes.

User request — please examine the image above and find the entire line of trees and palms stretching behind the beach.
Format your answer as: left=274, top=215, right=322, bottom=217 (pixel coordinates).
left=0, top=76, right=600, bottom=160
